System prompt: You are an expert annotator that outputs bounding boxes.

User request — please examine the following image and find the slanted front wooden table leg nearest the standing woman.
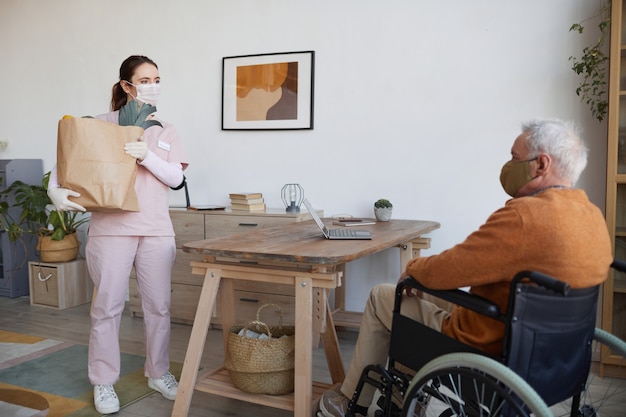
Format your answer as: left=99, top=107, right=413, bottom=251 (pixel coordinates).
left=172, top=269, right=222, bottom=417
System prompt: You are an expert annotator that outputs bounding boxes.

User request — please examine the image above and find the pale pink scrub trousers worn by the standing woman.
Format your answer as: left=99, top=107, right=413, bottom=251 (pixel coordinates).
left=86, top=236, right=176, bottom=385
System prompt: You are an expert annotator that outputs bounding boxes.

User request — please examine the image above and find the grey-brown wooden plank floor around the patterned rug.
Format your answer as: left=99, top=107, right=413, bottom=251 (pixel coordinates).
left=0, top=297, right=626, bottom=417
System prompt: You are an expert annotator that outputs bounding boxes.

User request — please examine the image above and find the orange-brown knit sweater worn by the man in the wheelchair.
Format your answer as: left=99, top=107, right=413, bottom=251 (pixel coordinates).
left=407, top=188, right=612, bottom=355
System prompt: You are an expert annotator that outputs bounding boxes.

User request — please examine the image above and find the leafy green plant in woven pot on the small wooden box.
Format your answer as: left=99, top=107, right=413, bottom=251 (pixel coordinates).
left=0, top=172, right=89, bottom=262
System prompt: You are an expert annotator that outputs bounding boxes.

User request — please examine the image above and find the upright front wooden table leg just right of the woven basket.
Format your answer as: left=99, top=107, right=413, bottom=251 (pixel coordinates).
left=294, top=277, right=313, bottom=417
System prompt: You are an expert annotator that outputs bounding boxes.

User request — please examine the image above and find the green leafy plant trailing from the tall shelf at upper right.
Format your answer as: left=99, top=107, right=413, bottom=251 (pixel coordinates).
left=569, top=1, right=611, bottom=122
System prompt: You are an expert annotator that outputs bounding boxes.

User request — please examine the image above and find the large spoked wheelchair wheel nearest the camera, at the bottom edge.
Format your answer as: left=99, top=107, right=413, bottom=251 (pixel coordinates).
left=402, top=353, right=553, bottom=417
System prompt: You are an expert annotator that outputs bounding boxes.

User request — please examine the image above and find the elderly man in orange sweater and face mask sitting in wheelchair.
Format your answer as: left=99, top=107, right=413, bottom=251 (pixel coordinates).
left=318, top=120, right=612, bottom=417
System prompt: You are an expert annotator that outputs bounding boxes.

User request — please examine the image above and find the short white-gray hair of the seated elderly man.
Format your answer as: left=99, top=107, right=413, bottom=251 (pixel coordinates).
left=522, top=120, right=589, bottom=184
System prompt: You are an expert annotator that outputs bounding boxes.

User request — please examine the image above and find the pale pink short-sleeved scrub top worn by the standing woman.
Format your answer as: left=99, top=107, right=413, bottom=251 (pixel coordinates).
left=89, top=111, right=187, bottom=236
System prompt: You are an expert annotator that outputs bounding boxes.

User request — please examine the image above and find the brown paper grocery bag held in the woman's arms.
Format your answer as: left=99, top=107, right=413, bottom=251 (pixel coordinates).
left=57, top=117, right=143, bottom=212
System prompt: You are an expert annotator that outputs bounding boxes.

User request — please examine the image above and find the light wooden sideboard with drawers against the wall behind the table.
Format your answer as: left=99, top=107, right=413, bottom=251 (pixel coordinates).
left=129, top=209, right=324, bottom=326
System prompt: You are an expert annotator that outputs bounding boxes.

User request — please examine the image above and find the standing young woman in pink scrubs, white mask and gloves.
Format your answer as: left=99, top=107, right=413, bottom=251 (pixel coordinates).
left=48, top=56, right=187, bottom=414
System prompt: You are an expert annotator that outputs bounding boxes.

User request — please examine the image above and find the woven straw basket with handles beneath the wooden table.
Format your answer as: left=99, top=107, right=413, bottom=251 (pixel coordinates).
left=224, top=304, right=295, bottom=395
